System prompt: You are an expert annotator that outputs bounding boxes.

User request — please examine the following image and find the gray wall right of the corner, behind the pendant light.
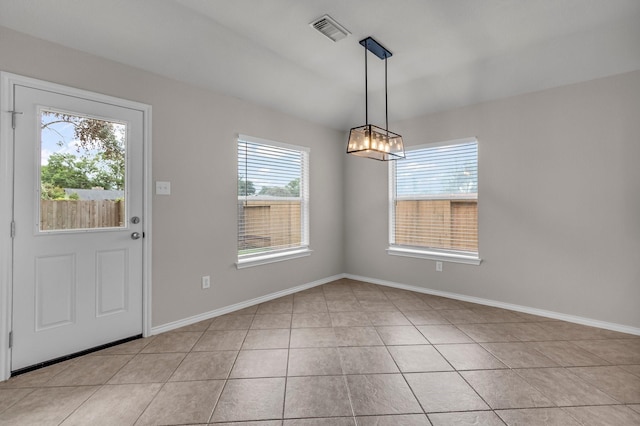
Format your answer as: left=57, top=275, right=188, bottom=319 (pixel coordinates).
left=345, top=71, right=640, bottom=327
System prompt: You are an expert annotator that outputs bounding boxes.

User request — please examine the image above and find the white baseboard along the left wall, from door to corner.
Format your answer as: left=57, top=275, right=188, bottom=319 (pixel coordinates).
left=151, top=274, right=346, bottom=335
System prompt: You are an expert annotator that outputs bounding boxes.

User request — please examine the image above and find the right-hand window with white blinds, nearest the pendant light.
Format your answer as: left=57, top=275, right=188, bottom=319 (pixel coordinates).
left=388, top=138, right=480, bottom=264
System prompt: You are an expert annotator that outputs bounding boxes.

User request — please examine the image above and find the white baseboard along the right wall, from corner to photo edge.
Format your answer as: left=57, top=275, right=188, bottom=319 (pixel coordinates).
left=345, top=274, right=640, bottom=336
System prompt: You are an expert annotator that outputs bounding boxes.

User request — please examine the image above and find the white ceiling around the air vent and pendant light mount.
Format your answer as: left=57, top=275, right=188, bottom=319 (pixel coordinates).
left=0, top=0, right=640, bottom=130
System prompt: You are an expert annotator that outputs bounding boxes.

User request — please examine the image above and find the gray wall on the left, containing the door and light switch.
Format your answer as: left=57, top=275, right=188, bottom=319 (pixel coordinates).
left=0, top=27, right=344, bottom=326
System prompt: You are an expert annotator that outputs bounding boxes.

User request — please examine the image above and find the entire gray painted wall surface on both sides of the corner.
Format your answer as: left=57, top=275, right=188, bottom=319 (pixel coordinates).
left=0, top=27, right=640, bottom=327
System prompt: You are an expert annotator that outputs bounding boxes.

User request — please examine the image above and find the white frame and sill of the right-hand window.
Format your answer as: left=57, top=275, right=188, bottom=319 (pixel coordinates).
left=387, top=137, right=482, bottom=265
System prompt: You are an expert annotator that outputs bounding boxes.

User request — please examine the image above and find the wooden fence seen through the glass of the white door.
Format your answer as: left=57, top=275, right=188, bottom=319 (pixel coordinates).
left=40, top=200, right=125, bottom=231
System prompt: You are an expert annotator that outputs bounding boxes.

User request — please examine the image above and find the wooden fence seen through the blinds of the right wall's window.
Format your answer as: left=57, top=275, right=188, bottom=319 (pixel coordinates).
left=395, top=200, right=478, bottom=251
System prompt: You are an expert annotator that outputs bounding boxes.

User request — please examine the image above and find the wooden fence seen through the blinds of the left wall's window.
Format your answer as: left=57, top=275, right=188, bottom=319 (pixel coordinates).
left=238, top=200, right=301, bottom=250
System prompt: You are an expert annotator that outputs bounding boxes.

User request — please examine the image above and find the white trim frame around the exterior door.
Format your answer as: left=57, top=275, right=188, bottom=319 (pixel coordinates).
left=0, top=71, right=153, bottom=381
